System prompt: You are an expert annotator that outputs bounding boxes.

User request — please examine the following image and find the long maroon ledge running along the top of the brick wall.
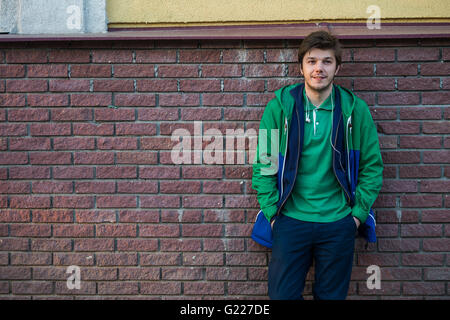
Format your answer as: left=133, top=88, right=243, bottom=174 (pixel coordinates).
left=0, top=23, right=450, bottom=42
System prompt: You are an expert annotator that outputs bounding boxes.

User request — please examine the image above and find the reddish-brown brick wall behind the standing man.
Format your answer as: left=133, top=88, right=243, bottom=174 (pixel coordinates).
left=0, top=39, right=450, bottom=299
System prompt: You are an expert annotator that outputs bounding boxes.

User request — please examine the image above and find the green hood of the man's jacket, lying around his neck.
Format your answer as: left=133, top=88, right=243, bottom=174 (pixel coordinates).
left=275, top=83, right=358, bottom=120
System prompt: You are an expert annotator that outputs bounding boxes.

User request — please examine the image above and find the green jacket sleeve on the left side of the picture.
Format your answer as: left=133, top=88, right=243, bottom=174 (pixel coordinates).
left=252, top=99, right=281, bottom=221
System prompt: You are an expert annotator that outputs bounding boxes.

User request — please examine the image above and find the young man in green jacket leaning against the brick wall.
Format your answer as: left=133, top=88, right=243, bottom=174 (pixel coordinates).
left=252, top=31, right=383, bottom=299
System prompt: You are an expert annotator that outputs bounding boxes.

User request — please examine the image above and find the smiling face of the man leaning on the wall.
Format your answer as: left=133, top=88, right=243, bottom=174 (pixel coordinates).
left=300, top=48, right=339, bottom=92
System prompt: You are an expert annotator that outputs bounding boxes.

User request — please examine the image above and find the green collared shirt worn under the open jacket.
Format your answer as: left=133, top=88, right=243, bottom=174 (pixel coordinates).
left=282, top=90, right=352, bottom=222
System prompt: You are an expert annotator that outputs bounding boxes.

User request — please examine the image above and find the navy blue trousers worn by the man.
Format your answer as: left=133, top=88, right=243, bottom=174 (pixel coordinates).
left=268, top=214, right=356, bottom=300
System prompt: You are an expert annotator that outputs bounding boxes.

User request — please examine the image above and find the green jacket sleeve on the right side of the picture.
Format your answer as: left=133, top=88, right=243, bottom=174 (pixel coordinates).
left=352, top=103, right=383, bottom=223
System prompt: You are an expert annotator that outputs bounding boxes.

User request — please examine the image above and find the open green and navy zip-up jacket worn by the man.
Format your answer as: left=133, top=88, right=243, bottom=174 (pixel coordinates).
left=252, top=83, right=383, bottom=239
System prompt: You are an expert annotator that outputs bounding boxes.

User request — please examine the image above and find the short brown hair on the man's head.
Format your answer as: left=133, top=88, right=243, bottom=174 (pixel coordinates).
left=298, top=30, right=342, bottom=67
